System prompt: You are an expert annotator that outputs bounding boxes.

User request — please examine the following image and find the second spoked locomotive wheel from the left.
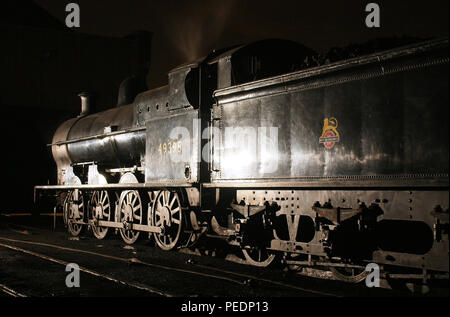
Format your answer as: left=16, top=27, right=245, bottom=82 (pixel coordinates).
left=90, top=190, right=112, bottom=240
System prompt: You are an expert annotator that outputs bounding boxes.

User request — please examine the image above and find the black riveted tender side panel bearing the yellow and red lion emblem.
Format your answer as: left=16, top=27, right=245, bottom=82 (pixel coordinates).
left=213, top=46, right=449, bottom=181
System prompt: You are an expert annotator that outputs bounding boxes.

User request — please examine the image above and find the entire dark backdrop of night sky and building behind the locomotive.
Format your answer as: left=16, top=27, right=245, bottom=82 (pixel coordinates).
left=0, top=0, right=448, bottom=212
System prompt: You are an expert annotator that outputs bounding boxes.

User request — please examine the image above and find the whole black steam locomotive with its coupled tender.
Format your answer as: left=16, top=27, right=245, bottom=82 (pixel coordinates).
left=35, top=39, right=449, bottom=281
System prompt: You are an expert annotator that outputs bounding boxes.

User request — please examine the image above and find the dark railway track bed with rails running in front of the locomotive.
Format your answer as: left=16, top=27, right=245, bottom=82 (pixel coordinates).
left=0, top=216, right=442, bottom=297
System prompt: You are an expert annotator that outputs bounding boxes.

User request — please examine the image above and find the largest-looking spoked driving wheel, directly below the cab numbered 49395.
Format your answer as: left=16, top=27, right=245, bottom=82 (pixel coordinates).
left=149, top=190, right=183, bottom=251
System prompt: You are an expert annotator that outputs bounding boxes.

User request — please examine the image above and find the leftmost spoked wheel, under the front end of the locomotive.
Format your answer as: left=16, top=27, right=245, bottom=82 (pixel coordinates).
left=63, top=189, right=85, bottom=237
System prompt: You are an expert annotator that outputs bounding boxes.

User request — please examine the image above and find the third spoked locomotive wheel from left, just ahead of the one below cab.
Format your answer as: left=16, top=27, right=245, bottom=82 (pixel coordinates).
left=116, top=190, right=144, bottom=244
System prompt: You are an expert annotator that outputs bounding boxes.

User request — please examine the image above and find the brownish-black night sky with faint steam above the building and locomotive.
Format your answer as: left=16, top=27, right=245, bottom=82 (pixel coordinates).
left=35, top=0, right=449, bottom=88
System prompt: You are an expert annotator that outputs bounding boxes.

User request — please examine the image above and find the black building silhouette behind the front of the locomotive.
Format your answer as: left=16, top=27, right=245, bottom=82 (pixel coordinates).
left=0, top=24, right=151, bottom=212
